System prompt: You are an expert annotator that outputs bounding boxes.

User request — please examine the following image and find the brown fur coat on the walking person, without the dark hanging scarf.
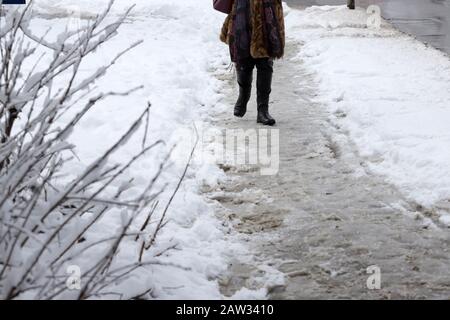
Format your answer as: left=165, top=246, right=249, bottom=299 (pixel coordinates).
left=220, top=0, right=285, bottom=59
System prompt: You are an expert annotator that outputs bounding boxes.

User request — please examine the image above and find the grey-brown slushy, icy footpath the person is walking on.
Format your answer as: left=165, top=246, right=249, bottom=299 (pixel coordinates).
left=209, top=40, right=450, bottom=299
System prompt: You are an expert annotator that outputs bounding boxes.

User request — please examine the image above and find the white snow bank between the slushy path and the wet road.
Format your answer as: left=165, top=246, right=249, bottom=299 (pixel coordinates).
left=286, top=6, right=450, bottom=223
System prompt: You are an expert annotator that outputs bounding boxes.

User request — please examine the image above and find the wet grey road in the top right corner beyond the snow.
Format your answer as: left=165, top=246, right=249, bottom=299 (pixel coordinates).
left=286, top=0, right=450, bottom=54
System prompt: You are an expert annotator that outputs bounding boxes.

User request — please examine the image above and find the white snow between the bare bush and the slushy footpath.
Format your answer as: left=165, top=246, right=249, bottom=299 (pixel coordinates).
left=23, top=0, right=253, bottom=299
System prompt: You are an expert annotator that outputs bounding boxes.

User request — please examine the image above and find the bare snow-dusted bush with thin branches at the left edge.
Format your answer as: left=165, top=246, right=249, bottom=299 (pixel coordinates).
left=0, top=1, right=184, bottom=299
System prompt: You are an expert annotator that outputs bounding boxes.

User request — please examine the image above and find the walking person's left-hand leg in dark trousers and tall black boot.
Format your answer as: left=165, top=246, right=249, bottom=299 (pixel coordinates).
left=234, top=58, right=255, bottom=118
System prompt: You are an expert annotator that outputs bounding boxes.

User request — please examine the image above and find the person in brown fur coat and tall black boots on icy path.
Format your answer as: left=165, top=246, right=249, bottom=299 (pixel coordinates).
left=220, top=0, right=285, bottom=126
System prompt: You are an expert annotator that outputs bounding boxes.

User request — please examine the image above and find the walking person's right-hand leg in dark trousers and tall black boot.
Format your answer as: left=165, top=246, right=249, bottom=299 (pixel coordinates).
left=256, top=59, right=275, bottom=126
